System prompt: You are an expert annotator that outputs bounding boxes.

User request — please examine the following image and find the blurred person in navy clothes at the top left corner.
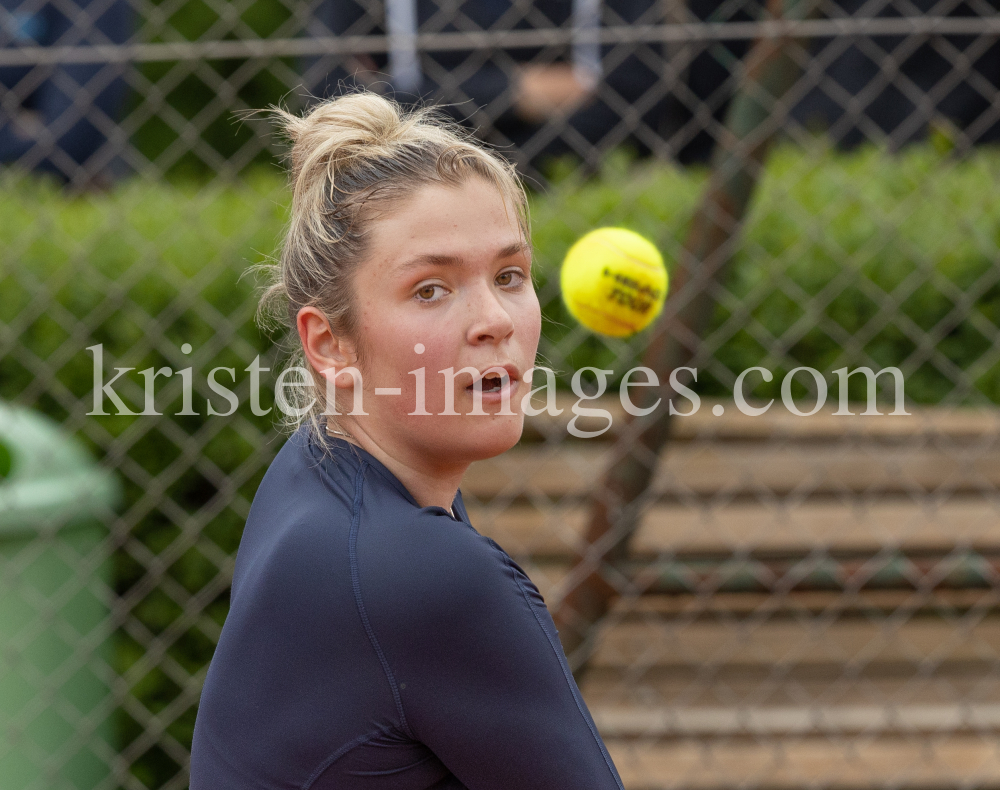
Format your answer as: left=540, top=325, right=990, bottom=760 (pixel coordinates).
left=0, top=0, right=132, bottom=188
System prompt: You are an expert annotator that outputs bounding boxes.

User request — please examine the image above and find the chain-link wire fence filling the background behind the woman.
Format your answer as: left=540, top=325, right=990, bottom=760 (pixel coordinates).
left=0, top=0, right=1000, bottom=790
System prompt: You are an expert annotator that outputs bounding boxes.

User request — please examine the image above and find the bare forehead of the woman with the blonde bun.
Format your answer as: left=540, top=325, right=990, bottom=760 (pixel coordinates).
left=371, top=179, right=523, bottom=257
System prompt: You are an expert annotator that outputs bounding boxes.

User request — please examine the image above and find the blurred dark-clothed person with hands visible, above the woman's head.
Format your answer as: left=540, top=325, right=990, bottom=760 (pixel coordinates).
left=306, top=0, right=665, bottom=169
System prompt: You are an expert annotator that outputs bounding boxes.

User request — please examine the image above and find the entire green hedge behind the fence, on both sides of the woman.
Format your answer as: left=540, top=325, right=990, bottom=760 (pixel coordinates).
left=0, top=141, right=1000, bottom=787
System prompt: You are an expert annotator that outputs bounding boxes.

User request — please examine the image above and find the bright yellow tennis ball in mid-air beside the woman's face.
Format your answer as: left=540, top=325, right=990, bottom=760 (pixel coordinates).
left=559, top=228, right=667, bottom=337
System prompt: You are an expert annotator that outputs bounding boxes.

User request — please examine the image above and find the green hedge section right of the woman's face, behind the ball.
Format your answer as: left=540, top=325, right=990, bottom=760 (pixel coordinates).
left=533, top=142, right=1000, bottom=403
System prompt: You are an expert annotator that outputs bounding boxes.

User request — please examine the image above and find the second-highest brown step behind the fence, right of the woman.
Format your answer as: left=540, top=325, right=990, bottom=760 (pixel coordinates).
left=461, top=439, right=1000, bottom=505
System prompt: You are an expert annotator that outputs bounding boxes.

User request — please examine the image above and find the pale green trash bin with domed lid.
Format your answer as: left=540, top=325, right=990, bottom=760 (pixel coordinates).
left=0, top=403, right=121, bottom=790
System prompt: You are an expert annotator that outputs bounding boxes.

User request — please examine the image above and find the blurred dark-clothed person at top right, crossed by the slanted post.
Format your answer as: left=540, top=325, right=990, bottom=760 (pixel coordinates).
left=664, top=0, right=1000, bottom=163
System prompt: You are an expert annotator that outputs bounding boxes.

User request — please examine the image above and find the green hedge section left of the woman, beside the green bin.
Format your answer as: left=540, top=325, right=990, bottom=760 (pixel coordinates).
left=0, top=173, right=286, bottom=787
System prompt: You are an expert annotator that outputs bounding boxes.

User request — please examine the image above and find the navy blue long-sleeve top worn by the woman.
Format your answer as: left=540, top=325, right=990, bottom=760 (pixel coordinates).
left=191, top=426, right=622, bottom=790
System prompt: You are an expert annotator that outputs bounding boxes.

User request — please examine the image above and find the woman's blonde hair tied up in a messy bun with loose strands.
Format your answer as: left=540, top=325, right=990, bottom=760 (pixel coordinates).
left=254, top=92, right=531, bottom=447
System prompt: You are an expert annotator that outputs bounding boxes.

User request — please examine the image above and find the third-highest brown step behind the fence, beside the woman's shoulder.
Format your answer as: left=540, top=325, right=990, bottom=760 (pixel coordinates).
left=469, top=496, right=1000, bottom=560
